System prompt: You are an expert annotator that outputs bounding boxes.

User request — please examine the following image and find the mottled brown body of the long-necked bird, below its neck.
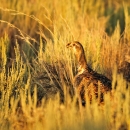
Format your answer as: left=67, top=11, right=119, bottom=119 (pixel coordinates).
left=74, top=71, right=112, bottom=102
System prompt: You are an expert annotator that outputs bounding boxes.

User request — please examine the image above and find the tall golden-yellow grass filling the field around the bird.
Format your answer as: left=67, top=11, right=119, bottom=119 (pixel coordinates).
left=0, top=0, right=130, bottom=130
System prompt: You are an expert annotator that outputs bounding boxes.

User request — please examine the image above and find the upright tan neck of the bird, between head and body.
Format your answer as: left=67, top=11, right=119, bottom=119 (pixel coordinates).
left=76, top=52, right=89, bottom=74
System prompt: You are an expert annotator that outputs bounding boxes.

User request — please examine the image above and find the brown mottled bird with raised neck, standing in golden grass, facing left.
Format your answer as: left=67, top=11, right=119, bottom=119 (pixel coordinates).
left=66, top=41, right=112, bottom=106
